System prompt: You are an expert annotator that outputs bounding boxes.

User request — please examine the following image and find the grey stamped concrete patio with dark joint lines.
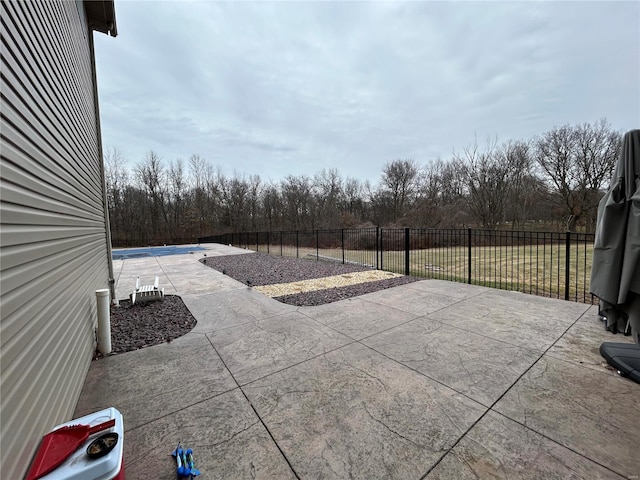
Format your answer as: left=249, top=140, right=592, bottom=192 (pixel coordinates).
left=75, top=244, right=640, bottom=480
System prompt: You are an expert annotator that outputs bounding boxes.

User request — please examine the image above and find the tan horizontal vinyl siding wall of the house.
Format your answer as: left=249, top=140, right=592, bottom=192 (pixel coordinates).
left=0, top=1, right=109, bottom=478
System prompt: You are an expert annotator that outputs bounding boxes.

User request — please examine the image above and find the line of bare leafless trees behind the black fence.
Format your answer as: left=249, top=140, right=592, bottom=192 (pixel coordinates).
left=105, top=119, right=622, bottom=247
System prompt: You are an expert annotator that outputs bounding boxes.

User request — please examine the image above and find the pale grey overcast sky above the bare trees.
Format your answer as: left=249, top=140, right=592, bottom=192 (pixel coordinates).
left=95, top=0, right=640, bottom=184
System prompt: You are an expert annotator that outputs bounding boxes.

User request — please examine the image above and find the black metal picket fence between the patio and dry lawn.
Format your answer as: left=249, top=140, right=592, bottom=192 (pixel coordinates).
left=198, top=227, right=594, bottom=303
